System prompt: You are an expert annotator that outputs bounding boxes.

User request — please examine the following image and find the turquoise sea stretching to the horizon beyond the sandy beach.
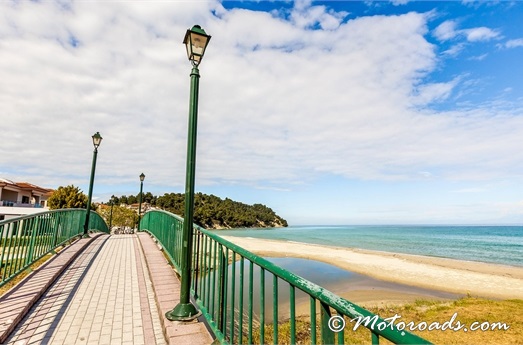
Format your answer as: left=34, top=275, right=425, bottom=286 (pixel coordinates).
left=216, top=225, right=523, bottom=266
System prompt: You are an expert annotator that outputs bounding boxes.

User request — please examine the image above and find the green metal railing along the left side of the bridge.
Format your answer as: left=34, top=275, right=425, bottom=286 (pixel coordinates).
left=0, top=209, right=109, bottom=286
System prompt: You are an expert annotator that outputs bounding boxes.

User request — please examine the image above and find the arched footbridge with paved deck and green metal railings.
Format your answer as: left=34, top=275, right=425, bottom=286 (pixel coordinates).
left=0, top=209, right=428, bottom=344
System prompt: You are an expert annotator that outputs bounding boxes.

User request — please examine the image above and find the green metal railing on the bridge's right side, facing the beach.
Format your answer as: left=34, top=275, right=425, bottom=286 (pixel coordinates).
left=141, top=211, right=429, bottom=344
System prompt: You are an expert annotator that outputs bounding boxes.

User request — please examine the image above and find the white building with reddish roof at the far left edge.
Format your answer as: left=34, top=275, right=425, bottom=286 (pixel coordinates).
left=0, top=178, right=53, bottom=221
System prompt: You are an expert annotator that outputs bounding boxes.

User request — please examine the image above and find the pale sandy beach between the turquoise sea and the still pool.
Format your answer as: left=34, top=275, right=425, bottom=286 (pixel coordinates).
left=223, top=236, right=523, bottom=304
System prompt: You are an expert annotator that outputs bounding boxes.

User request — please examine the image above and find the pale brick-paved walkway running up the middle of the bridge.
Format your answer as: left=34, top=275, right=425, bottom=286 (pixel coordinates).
left=7, top=234, right=212, bottom=345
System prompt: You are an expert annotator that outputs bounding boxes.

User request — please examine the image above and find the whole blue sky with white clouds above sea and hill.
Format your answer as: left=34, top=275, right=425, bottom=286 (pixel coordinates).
left=0, top=0, right=523, bottom=225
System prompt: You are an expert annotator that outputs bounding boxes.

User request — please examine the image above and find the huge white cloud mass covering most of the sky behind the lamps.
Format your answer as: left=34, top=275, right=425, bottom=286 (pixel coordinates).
left=0, top=2, right=523, bottom=202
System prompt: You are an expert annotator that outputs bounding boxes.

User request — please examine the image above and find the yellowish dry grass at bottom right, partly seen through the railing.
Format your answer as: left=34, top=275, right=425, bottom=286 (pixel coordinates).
left=253, top=297, right=523, bottom=345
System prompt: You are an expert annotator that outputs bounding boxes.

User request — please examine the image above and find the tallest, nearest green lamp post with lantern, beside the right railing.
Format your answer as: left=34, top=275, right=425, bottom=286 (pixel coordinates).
left=165, top=25, right=211, bottom=321
